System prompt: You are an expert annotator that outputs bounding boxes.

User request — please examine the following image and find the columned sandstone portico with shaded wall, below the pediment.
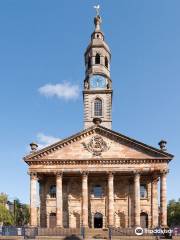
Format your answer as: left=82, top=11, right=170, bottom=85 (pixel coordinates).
left=27, top=156, right=170, bottom=228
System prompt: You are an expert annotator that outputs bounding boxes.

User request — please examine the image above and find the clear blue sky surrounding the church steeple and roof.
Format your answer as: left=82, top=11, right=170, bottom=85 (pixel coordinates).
left=0, top=0, right=180, bottom=202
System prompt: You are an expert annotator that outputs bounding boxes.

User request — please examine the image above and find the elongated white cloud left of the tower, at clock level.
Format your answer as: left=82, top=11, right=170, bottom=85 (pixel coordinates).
left=38, top=82, right=79, bottom=100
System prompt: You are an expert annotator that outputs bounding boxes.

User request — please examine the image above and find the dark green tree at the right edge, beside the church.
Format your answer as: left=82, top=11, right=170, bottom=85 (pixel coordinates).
left=167, top=199, right=180, bottom=227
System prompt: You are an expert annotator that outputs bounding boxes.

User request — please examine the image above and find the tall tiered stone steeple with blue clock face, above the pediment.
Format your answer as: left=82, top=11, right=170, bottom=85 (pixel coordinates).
left=83, top=12, right=112, bottom=129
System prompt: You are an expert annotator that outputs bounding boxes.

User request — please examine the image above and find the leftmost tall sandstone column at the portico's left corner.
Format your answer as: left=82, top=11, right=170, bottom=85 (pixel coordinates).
left=30, top=173, right=37, bottom=227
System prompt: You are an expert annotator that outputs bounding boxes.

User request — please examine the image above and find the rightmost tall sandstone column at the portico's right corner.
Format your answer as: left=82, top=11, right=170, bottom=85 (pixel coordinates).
left=160, top=171, right=167, bottom=227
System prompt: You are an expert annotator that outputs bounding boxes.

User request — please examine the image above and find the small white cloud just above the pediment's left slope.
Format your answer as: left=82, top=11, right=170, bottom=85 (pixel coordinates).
left=37, top=133, right=61, bottom=149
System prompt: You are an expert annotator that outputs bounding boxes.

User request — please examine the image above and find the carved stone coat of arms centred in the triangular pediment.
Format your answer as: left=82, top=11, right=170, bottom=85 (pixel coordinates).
left=82, top=135, right=109, bottom=156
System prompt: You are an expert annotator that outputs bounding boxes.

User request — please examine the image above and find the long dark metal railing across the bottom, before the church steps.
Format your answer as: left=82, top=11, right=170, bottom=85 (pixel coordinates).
left=0, top=226, right=178, bottom=239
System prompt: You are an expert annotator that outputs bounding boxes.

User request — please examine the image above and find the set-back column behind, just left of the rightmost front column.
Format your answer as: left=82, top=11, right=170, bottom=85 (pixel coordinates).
left=151, top=176, right=158, bottom=228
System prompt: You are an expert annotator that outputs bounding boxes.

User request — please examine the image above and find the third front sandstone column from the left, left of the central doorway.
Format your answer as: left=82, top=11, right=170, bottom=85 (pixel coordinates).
left=82, top=172, right=88, bottom=227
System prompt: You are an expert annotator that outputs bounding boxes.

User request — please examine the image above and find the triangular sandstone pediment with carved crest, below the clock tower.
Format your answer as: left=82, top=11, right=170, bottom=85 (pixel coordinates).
left=24, top=126, right=173, bottom=162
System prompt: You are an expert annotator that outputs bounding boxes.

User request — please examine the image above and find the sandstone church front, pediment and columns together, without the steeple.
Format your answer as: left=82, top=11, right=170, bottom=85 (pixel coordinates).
left=25, top=125, right=172, bottom=228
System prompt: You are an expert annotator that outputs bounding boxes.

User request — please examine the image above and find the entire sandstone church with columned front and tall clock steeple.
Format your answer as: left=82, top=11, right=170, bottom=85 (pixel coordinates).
left=24, top=14, right=173, bottom=228
